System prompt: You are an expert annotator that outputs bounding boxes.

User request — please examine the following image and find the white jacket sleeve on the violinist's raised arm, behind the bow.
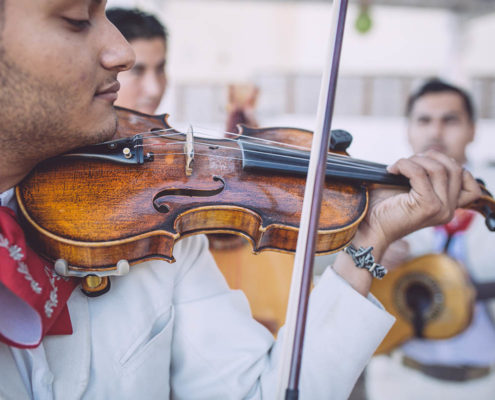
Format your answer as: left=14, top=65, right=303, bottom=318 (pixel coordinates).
left=171, top=238, right=393, bottom=400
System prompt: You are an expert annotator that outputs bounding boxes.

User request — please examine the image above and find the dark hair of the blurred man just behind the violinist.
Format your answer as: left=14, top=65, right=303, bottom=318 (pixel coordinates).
left=106, top=7, right=168, bottom=42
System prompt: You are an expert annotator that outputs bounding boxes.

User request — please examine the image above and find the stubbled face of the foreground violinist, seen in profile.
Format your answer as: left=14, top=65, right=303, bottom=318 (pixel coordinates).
left=0, top=0, right=134, bottom=163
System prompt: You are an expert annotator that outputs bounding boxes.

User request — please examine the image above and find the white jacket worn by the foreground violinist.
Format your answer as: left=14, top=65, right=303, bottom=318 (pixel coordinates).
left=0, top=236, right=393, bottom=400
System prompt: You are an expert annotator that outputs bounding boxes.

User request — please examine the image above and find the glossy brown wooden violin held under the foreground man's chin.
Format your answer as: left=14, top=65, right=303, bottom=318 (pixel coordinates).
left=16, top=108, right=495, bottom=294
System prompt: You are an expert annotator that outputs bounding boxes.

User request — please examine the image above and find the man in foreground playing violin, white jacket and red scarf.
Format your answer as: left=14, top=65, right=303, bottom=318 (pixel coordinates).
left=0, top=0, right=480, bottom=400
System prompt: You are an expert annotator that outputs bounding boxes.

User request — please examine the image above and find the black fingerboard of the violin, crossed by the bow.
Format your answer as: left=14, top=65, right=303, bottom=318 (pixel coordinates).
left=239, top=139, right=409, bottom=187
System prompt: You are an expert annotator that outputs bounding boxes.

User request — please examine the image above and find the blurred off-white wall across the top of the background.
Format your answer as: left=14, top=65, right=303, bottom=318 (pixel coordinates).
left=104, top=0, right=495, bottom=82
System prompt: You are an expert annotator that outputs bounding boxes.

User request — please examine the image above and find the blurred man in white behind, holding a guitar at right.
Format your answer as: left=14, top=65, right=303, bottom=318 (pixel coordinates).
left=367, top=79, right=495, bottom=400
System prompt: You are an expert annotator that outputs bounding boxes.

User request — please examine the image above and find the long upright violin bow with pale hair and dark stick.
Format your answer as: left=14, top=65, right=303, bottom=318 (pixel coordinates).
left=277, top=0, right=348, bottom=400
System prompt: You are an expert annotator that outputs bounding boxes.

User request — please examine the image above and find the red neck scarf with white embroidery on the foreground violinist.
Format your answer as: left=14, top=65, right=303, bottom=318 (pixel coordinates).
left=0, top=206, right=78, bottom=348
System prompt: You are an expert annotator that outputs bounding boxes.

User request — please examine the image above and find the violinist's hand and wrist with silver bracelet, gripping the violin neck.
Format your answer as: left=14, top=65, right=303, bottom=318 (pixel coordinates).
left=334, top=151, right=481, bottom=295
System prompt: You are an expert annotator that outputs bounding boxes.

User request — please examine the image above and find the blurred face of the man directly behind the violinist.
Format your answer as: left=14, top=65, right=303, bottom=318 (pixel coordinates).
left=116, top=38, right=167, bottom=114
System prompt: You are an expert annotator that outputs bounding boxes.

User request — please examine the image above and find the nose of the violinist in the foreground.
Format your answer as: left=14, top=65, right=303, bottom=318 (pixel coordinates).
left=100, top=20, right=136, bottom=72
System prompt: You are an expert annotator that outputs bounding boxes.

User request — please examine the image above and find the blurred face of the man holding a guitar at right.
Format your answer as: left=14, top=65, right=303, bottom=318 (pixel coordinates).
left=408, top=92, right=474, bottom=163
